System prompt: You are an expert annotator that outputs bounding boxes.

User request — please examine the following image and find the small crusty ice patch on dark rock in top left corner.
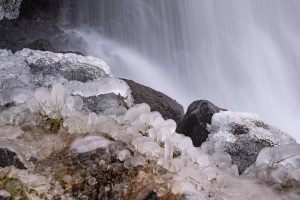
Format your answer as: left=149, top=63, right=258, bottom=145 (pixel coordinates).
left=0, top=0, right=22, bottom=20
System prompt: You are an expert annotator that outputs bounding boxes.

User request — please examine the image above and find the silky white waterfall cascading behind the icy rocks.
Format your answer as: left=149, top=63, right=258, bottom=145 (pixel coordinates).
left=56, top=0, right=300, bottom=141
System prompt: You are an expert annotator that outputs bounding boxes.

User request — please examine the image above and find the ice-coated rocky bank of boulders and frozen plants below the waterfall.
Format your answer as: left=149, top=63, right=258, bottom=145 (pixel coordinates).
left=0, top=0, right=300, bottom=200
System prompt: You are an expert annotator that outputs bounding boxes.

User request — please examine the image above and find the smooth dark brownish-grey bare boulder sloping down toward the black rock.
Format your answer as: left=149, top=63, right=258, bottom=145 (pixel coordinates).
left=123, top=79, right=184, bottom=123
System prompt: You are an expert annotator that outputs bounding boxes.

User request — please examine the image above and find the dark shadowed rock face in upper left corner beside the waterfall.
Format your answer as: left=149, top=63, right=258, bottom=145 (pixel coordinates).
left=0, top=0, right=62, bottom=52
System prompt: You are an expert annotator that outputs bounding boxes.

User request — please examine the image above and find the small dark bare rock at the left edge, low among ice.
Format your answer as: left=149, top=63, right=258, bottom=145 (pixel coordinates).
left=0, top=148, right=26, bottom=170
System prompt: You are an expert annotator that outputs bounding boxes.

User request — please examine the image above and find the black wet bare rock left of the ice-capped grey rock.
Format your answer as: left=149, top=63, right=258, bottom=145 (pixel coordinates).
left=176, top=100, right=224, bottom=146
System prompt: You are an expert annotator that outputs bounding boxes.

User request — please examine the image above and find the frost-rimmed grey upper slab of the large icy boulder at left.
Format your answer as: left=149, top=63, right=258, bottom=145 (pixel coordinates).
left=15, top=49, right=110, bottom=82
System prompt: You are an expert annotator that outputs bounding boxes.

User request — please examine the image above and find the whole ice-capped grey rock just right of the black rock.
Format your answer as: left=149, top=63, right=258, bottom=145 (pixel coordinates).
left=202, top=111, right=296, bottom=172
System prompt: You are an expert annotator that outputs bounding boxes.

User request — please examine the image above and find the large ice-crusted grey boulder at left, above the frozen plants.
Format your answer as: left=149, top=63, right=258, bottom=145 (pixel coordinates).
left=0, top=49, right=132, bottom=112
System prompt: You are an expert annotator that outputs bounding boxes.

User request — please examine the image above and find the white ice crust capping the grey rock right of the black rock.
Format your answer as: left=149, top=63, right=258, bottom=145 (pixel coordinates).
left=208, top=111, right=296, bottom=150
